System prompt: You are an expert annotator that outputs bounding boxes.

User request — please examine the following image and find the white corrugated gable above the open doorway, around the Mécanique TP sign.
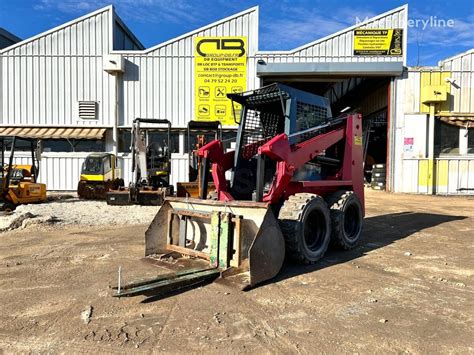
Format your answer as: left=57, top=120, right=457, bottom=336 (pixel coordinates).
left=257, top=5, right=408, bottom=64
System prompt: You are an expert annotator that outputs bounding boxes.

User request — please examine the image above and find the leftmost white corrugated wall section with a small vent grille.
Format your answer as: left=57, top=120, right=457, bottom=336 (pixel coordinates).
left=0, top=7, right=113, bottom=126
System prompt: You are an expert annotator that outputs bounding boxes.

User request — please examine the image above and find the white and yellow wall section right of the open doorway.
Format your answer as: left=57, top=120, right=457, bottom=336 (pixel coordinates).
left=395, top=50, right=474, bottom=194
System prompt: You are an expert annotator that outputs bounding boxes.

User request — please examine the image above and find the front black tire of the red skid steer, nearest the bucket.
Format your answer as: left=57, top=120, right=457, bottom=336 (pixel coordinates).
left=278, top=193, right=331, bottom=264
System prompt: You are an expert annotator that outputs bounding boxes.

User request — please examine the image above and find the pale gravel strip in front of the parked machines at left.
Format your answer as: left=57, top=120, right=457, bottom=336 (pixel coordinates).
left=0, top=198, right=158, bottom=232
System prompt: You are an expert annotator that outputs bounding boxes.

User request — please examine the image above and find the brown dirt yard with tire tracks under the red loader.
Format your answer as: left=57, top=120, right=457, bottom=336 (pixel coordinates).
left=0, top=191, right=474, bottom=353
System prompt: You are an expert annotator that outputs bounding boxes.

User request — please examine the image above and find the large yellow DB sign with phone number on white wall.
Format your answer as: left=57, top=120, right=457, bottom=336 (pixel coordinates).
left=194, top=37, right=247, bottom=125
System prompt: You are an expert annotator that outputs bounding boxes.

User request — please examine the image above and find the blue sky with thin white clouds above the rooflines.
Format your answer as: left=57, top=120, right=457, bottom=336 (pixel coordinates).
left=0, top=0, right=474, bottom=66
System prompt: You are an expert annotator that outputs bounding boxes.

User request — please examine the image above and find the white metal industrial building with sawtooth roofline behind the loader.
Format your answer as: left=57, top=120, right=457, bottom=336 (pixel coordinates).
left=0, top=5, right=474, bottom=194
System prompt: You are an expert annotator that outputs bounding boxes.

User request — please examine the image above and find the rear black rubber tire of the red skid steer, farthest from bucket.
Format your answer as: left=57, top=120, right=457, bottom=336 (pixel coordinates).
left=327, top=190, right=364, bottom=250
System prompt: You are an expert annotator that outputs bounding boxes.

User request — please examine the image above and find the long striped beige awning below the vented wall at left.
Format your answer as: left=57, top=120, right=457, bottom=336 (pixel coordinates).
left=0, top=127, right=106, bottom=139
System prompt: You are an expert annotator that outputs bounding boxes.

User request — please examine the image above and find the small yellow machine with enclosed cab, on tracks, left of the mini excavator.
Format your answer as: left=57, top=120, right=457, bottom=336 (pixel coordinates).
left=77, top=153, right=124, bottom=200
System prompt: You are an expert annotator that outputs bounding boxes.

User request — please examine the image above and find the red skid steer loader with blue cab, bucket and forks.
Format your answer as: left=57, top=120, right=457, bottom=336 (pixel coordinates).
left=118, top=84, right=364, bottom=296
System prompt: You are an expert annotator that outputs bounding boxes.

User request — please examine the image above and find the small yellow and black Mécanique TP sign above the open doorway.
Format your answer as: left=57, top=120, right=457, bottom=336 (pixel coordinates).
left=354, top=28, right=403, bottom=56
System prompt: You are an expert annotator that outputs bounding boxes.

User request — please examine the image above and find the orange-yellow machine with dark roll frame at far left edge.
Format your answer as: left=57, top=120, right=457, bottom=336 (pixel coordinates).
left=0, top=137, right=46, bottom=211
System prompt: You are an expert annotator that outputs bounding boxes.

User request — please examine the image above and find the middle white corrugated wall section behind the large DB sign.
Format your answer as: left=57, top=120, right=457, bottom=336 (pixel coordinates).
left=119, top=8, right=258, bottom=128
